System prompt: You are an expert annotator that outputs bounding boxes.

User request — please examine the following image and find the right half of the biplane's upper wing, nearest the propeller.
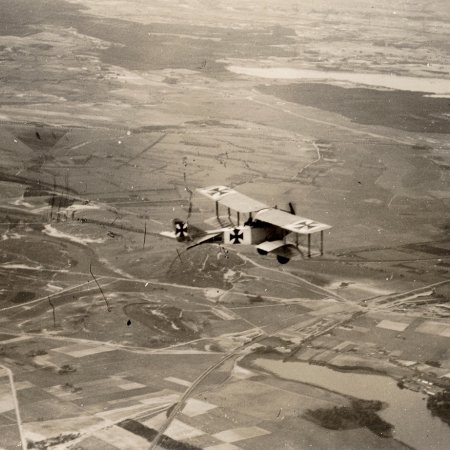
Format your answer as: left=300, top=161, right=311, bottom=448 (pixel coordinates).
left=255, top=208, right=331, bottom=234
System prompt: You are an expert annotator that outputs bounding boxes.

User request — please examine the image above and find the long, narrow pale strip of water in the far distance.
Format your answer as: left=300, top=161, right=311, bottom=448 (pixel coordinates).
left=227, top=65, right=450, bottom=97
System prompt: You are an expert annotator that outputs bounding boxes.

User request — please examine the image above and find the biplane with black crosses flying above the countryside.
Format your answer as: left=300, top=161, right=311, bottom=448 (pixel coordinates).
left=161, top=186, right=331, bottom=264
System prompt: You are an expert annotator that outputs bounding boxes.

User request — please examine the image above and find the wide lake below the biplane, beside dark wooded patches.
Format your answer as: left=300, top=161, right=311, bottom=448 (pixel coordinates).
left=254, top=358, right=450, bottom=450
